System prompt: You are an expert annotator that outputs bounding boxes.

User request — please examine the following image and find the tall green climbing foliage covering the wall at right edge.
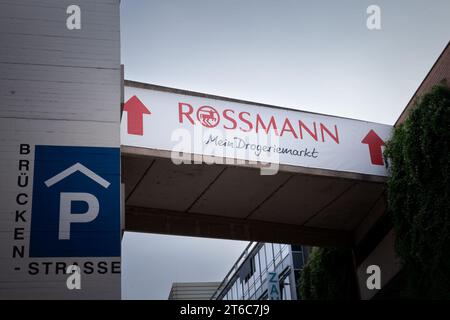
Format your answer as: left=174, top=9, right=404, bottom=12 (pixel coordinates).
left=385, top=86, right=450, bottom=299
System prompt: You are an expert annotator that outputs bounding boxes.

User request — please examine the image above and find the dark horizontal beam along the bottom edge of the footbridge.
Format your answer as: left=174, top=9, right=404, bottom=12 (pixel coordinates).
left=125, top=206, right=352, bottom=247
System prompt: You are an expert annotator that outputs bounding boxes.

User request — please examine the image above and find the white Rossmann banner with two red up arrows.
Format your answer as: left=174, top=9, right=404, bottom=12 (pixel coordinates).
left=121, top=86, right=392, bottom=176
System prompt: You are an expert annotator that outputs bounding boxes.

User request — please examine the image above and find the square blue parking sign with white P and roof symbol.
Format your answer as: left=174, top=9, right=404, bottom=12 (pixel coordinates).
left=30, top=145, right=121, bottom=257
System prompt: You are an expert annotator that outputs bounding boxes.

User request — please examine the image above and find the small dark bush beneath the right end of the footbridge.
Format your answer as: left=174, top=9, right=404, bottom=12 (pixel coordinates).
left=299, top=247, right=356, bottom=300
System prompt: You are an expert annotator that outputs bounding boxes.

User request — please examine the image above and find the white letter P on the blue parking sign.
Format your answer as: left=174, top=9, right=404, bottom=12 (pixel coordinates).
left=58, top=192, right=100, bottom=240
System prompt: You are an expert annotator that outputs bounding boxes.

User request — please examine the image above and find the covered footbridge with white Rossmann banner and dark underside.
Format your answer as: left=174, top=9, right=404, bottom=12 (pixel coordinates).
left=121, top=81, right=391, bottom=246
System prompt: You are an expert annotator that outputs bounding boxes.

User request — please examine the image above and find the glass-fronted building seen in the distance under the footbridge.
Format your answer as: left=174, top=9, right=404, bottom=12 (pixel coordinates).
left=211, top=242, right=309, bottom=300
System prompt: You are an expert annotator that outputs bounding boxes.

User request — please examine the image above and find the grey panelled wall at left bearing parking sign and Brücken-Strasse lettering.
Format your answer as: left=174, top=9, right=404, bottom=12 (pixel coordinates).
left=0, top=0, right=121, bottom=299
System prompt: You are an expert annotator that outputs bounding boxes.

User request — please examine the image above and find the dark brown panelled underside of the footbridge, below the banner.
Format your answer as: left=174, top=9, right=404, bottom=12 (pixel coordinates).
left=122, top=146, right=385, bottom=246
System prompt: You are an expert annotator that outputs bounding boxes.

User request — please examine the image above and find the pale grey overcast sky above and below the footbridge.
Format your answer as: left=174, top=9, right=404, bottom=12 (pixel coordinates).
left=121, top=0, right=450, bottom=299
